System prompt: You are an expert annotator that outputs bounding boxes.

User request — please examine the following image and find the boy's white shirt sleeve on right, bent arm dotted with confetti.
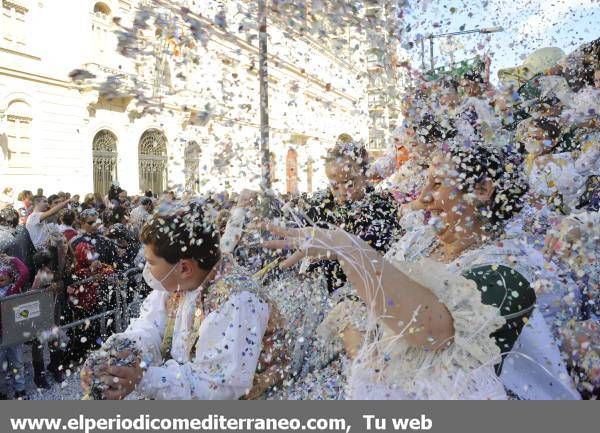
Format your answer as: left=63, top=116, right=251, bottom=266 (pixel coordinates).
left=138, top=292, right=269, bottom=400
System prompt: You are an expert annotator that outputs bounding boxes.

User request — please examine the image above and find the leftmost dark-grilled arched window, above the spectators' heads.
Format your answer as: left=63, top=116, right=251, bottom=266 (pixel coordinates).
left=92, top=129, right=118, bottom=196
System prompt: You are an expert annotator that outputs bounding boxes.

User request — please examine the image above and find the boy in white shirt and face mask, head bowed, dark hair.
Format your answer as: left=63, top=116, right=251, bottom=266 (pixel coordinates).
left=81, top=203, right=280, bottom=400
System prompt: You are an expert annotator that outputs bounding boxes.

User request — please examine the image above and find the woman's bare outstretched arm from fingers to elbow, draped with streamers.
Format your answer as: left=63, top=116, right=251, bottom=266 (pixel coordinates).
left=265, top=226, right=454, bottom=349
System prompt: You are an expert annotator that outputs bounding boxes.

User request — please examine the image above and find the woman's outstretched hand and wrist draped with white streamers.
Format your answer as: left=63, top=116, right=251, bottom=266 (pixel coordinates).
left=263, top=224, right=354, bottom=269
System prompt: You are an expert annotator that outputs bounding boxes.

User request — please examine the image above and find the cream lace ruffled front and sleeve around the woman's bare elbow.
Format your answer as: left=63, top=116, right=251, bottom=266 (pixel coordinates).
left=347, top=259, right=506, bottom=400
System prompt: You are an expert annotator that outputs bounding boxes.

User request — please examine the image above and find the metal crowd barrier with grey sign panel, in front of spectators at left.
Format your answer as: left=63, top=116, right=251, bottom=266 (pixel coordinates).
left=0, top=267, right=141, bottom=349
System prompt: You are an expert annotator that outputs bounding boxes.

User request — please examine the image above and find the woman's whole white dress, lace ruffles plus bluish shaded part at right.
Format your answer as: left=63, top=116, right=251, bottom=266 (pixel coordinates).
left=348, top=235, right=580, bottom=400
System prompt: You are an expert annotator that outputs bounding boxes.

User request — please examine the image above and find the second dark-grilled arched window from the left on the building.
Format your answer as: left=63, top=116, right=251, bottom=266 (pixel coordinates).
left=139, top=129, right=167, bottom=193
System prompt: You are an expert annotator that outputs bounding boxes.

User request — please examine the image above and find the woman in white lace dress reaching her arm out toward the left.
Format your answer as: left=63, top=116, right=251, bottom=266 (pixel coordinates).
left=267, top=141, right=576, bottom=399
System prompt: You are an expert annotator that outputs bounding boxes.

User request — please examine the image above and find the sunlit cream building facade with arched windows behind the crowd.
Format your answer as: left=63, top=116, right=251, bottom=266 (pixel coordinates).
left=0, top=0, right=398, bottom=194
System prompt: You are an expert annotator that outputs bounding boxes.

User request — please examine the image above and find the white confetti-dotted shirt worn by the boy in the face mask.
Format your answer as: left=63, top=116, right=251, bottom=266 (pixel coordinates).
left=123, top=268, right=269, bottom=400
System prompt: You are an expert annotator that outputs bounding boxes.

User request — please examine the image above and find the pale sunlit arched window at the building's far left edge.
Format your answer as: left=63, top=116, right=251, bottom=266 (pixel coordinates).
left=4, top=101, right=33, bottom=168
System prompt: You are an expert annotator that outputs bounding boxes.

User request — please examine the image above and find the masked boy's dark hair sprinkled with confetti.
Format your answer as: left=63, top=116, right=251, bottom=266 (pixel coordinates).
left=140, top=202, right=221, bottom=270
